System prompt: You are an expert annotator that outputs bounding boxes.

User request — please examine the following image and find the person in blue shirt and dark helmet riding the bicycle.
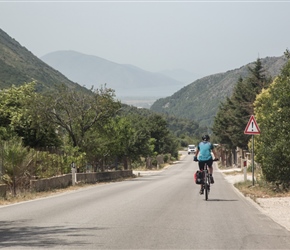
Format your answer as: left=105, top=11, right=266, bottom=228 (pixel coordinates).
left=193, top=135, right=218, bottom=194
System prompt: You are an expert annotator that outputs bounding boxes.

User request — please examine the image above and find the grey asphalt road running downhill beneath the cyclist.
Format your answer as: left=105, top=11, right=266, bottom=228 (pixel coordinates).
left=0, top=151, right=290, bottom=249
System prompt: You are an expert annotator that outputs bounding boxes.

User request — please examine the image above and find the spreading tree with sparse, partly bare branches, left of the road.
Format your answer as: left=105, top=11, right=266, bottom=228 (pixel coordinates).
left=39, top=85, right=120, bottom=148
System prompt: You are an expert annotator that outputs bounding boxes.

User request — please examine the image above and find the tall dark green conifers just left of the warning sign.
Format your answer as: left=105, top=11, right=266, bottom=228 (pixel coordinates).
left=212, top=59, right=270, bottom=149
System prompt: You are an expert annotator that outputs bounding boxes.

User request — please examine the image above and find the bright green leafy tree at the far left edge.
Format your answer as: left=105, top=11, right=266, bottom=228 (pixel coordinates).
left=0, top=82, right=59, bottom=147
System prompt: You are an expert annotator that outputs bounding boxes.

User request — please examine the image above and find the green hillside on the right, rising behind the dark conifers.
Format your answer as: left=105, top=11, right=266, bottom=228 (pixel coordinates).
left=151, top=56, right=286, bottom=126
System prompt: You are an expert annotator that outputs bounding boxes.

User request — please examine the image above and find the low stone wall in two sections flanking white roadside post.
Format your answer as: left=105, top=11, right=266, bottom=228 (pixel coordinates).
left=30, top=170, right=133, bottom=192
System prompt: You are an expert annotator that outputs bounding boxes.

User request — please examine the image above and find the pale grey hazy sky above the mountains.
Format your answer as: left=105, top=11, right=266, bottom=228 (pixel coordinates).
left=0, top=0, right=290, bottom=76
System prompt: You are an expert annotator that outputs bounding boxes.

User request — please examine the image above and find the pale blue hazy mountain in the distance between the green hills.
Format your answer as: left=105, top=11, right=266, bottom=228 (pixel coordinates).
left=41, top=51, right=185, bottom=97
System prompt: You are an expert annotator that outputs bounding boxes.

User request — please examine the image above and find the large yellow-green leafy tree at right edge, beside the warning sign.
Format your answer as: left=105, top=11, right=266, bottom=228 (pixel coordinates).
left=254, top=56, right=290, bottom=188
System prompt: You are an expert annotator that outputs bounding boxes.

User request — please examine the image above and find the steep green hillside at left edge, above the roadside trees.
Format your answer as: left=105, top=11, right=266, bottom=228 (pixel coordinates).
left=0, top=29, right=85, bottom=91
